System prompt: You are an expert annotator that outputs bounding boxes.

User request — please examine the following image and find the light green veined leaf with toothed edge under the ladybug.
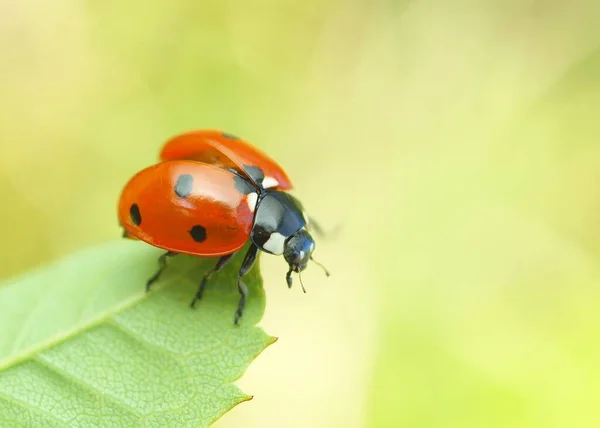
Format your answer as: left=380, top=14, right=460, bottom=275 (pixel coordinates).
left=0, top=240, right=274, bottom=427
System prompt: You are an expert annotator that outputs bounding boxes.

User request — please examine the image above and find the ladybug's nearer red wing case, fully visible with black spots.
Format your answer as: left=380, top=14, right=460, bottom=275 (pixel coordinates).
left=118, top=160, right=255, bottom=256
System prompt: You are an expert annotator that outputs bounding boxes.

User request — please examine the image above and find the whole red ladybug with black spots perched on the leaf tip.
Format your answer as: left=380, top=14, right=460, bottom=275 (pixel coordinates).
left=118, top=130, right=329, bottom=324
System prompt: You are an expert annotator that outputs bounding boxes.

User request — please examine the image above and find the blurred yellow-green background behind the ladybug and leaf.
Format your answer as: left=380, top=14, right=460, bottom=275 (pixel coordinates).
left=0, top=0, right=600, bottom=428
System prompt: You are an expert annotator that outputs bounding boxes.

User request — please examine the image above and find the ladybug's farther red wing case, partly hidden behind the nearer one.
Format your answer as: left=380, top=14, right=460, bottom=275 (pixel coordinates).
left=160, top=130, right=293, bottom=190
